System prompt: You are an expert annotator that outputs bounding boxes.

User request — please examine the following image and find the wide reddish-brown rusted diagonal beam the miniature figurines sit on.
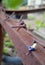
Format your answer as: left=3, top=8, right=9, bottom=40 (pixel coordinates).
left=0, top=12, right=45, bottom=65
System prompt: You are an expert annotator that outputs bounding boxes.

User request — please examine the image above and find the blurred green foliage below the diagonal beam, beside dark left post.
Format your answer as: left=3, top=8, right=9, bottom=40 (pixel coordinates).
left=3, top=32, right=14, bottom=55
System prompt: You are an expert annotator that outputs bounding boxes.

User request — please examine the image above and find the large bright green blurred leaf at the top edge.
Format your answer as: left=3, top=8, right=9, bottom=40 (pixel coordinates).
left=2, top=0, right=23, bottom=9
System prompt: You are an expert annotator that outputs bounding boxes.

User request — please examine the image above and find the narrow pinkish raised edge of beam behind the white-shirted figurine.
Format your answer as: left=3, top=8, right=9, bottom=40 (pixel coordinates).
left=27, top=31, right=45, bottom=48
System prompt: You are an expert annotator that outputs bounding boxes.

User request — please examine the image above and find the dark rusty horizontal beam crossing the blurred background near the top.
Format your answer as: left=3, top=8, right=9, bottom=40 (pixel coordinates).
left=5, top=7, right=45, bottom=15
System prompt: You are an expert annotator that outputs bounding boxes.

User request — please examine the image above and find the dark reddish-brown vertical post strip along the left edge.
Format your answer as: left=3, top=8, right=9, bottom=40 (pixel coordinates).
left=0, top=24, right=4, bottom=65
